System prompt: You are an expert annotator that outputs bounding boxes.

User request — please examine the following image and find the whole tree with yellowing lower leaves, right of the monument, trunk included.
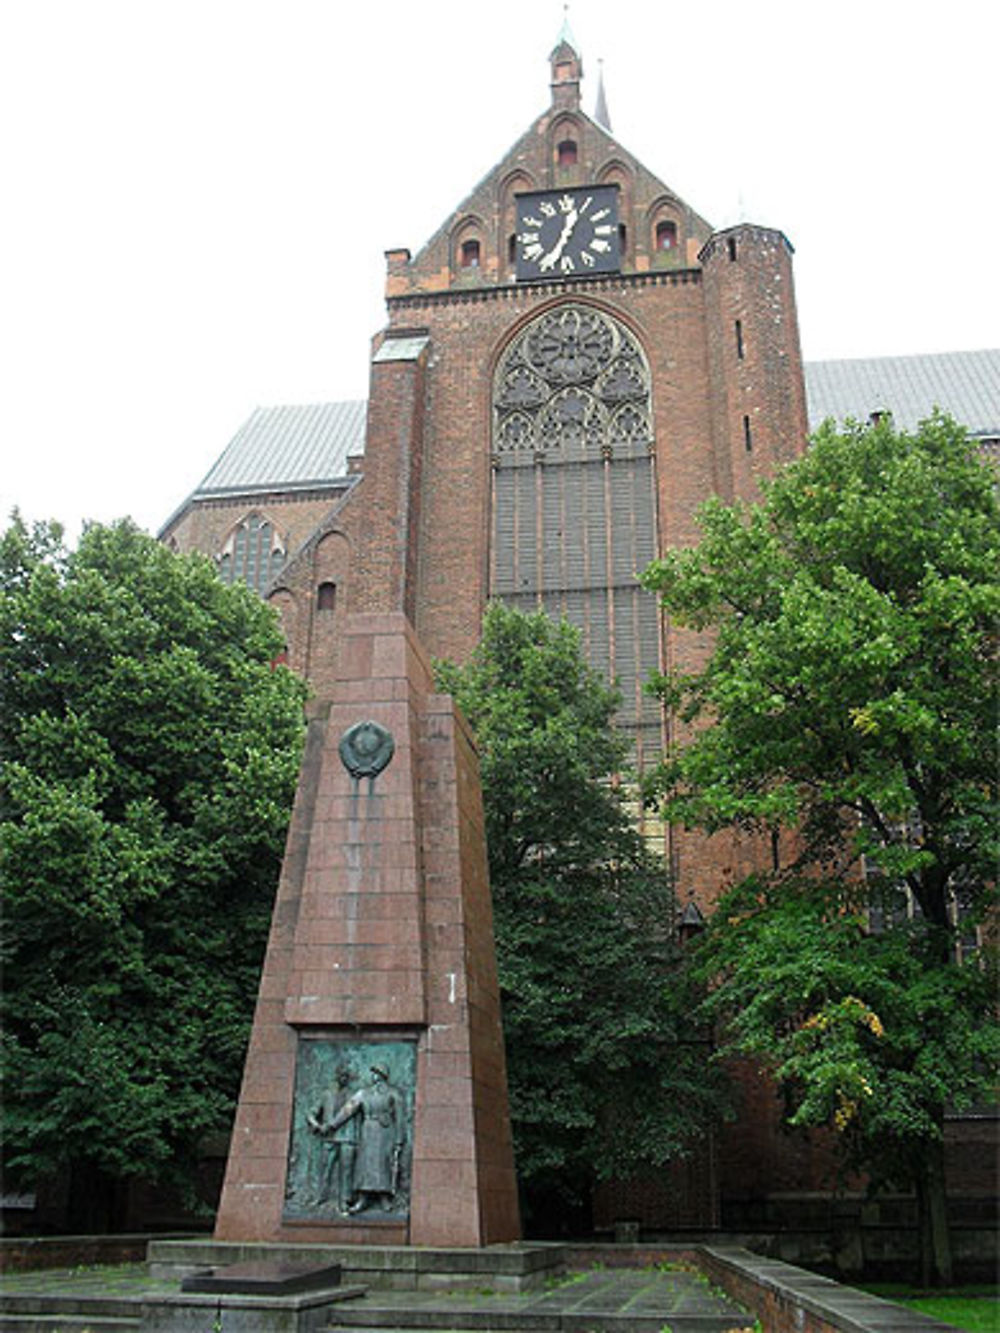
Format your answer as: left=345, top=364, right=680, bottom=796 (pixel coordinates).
left=643, top=416, right=1000, bottom=1281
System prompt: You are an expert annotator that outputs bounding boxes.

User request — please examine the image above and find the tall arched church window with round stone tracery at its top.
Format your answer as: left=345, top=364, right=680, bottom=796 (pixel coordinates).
left=491, top=303, right=661, bottom=766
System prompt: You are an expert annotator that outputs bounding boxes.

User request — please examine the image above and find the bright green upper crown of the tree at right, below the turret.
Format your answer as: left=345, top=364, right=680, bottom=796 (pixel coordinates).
left=643, top=417, right=1000, bottom=929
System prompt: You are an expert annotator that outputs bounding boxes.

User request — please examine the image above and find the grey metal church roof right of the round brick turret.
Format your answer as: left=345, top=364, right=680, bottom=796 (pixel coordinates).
left=804, top=349, right=1000, bottom=437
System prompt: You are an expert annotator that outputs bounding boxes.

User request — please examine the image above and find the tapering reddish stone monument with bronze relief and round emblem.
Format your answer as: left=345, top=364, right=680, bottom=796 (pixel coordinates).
left=215, top=611, right=520, bottom=1246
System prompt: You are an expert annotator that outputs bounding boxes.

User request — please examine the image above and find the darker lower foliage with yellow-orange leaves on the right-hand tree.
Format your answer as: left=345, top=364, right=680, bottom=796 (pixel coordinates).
left=699, top=878, right=1000, bottom=1184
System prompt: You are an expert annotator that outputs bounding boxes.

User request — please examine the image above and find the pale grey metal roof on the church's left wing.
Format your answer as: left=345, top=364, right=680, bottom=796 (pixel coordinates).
left=191, top=399, right=368, bottom=500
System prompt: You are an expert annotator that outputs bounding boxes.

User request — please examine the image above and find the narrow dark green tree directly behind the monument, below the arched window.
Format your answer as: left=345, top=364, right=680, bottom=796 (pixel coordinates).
left=439, top=603, right=717, bottom=1226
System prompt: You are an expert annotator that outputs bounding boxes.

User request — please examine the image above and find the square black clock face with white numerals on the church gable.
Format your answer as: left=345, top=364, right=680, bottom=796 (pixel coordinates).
left=516, top=185, right=621, bottom=283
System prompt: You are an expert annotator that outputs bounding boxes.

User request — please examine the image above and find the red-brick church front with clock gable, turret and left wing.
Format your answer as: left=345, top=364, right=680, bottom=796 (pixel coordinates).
left=163, top=29, right=807, bottom=1225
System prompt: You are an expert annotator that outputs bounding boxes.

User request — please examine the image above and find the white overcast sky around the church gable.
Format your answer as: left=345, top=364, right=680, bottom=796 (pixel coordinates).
left=0, top=0, right=1000, bottom=536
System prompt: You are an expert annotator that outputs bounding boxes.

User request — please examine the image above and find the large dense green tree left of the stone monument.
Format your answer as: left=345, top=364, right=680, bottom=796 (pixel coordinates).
left=0, top=515, right=303, bottom=1226
